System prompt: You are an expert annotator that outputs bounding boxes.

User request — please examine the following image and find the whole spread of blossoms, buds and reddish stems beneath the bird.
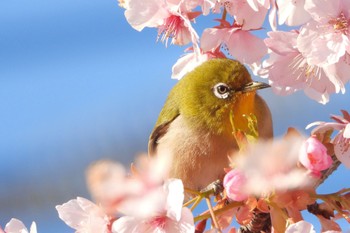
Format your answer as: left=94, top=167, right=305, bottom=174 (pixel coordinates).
left=52, top=122, right=350, bottom=233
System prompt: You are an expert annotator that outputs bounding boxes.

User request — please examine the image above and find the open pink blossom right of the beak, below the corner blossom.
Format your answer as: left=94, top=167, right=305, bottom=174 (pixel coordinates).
left=260, top=31, right=343, bottom=104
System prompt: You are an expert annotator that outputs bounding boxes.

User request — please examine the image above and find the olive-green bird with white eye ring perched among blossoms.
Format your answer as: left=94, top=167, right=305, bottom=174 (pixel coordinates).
left=148, top=58, right=273, bottom=191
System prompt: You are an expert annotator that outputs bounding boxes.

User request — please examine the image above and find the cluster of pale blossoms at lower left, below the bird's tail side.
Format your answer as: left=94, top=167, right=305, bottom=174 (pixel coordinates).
left=56, top=156, right=194, bottom=233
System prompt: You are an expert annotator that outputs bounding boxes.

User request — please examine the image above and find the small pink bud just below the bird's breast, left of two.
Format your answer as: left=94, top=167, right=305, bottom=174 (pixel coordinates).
left=223, top=169, right=248, bottom=201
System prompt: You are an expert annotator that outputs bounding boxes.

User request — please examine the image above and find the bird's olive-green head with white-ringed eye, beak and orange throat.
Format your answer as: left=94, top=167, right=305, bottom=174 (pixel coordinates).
left=174, top=59, right=269, bottom=134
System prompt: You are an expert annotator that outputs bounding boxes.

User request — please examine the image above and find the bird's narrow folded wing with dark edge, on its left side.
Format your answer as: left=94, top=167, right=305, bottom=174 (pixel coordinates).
left=148, top=101, right=180, bottom=156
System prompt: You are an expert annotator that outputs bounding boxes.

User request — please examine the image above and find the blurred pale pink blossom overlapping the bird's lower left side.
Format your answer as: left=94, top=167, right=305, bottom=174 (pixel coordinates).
left=87, top=155, right=171, bottom=216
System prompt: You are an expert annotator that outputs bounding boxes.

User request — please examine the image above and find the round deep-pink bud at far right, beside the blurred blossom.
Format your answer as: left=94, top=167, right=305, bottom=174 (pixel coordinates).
left=299, top=136, right=332, bottom=175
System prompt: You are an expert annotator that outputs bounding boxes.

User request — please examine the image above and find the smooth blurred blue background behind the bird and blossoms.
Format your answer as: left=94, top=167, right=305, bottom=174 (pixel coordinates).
left=0, top=0, right=350, bottom=233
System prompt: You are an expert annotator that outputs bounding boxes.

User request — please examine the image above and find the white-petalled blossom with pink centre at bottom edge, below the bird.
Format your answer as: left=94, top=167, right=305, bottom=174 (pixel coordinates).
left=112, top=179, right=194, bottom=233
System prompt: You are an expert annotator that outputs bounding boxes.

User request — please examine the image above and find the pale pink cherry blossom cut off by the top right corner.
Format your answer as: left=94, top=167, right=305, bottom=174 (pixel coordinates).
left=297, top=0, right=350, bottom=66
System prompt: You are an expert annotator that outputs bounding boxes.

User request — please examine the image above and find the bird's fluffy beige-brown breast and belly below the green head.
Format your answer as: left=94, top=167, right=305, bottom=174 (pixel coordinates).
left=156, top=115, right=237, bottom=190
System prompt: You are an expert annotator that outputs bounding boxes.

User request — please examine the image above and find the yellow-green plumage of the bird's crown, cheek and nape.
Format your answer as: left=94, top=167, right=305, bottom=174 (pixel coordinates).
left=156, top=59, right=252, bottom=134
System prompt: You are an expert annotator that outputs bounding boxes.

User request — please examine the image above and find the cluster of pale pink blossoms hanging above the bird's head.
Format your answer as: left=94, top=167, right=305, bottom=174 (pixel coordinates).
left=119, top=0, right=350, bottom=104
